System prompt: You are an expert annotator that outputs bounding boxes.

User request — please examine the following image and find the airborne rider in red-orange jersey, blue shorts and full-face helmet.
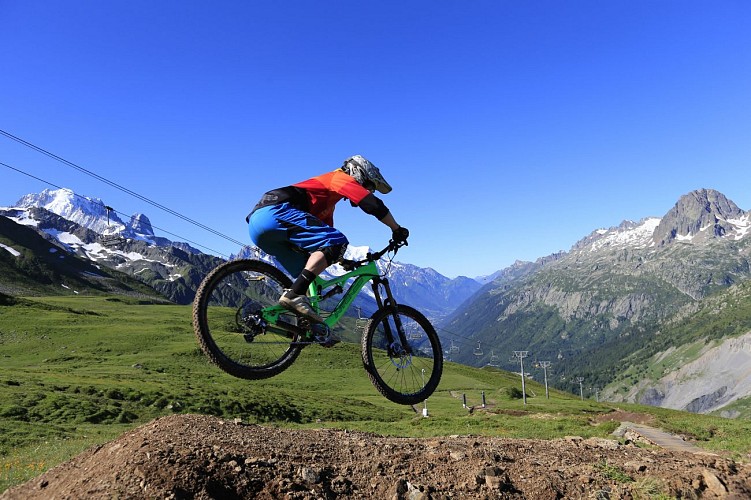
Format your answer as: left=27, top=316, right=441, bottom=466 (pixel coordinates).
left=245, top=155, right=409, bottom=323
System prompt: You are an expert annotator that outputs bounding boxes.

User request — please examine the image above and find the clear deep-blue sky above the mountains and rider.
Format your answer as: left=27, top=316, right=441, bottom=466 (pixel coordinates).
left=0, top=0, right=751, bottom=277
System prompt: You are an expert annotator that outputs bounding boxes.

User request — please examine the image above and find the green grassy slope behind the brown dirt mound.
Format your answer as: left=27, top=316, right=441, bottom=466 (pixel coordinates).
left=0, top=296, right=751, bottom=491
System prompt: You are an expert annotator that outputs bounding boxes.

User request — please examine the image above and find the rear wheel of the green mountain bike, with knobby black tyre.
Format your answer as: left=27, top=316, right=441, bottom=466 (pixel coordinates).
left=193, top=260, right=301, bottom=380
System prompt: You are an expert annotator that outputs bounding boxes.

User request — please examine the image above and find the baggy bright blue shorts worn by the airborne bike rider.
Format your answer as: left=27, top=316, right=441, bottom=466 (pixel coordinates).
left=248, top=203, right=349, bottom=277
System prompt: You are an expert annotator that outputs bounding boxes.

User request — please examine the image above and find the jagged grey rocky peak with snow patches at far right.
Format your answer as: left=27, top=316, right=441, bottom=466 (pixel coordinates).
left=653, top=189, right=745, bottom=245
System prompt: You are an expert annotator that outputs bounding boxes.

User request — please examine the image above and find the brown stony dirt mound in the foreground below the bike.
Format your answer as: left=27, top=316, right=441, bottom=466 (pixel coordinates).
left=0, top=415, right=751, bottom=500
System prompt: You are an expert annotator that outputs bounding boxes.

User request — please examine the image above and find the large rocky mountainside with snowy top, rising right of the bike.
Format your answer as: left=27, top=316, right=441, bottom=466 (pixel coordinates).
left=440, top=189, right=751, bottom=414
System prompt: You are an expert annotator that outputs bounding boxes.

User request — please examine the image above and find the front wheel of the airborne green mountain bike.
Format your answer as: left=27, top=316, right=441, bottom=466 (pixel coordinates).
left=362, top=305, right=443, bottom=405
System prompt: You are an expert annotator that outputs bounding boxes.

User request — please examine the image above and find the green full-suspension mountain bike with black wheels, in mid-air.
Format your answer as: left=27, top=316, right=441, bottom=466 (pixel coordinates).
left=193, top=241, right=443, bottom=405
